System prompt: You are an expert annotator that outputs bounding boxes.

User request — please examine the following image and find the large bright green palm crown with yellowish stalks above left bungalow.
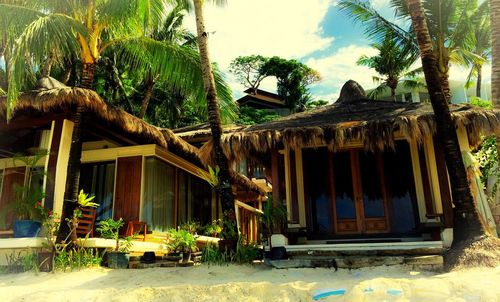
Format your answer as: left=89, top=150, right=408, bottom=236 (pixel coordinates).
left=0, top=0, right=232, bottom=114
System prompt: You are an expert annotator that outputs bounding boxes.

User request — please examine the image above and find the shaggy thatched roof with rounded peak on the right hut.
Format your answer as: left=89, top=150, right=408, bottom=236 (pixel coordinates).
left=201, top=81, right=500, bottom=161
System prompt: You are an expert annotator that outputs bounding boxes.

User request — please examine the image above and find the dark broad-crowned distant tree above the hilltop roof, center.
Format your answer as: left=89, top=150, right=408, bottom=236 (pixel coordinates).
left=230, top=55, right=321, bottom=112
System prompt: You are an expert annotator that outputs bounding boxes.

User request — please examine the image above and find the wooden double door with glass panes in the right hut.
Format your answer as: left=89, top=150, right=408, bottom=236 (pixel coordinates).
left=330, top=150, right=389, bottom=234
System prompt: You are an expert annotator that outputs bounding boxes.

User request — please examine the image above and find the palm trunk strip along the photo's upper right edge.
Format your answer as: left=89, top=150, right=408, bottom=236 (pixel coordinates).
left=490, top=0, right=500, bottom=105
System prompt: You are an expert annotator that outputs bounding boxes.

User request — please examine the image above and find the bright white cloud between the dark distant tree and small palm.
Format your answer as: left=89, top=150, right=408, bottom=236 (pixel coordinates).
left=305, top=45, right=377, bottom=101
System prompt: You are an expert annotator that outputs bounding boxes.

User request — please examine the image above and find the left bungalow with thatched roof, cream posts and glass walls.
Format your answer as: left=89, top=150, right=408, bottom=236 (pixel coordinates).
left=0, top=81, right=263, bottom=242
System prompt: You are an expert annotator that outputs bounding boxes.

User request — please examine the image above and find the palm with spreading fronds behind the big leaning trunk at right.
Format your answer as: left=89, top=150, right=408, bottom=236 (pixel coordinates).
left=339, top=0, right=482, bottom=101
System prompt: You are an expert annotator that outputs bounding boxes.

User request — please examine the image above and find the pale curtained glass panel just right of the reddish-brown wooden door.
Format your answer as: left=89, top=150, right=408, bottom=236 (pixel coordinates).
left=141, top=157, right=175, bottom=232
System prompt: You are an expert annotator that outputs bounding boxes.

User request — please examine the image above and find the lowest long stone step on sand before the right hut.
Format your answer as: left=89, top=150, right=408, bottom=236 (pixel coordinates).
left=269, top=255, right=443, bottom=270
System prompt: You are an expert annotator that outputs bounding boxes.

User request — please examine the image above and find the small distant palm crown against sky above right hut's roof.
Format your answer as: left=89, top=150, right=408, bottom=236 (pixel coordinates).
left=357, top=34, right=421, bottom=101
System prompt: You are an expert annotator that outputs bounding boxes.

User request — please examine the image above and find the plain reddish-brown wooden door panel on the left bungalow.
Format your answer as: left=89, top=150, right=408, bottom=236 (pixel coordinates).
left=113, top=156, right=142, bottom=222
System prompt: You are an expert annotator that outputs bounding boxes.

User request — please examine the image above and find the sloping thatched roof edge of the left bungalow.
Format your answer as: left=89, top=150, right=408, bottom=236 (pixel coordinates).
left=0, top=87, right=200, bottom=165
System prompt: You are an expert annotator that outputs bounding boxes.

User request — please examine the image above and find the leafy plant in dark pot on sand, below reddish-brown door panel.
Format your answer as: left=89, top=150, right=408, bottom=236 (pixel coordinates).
left=97, top=218, right=132, bottom=268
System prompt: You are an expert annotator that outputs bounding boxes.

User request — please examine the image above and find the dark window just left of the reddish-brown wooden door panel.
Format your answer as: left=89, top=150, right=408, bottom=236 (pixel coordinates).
left=80, top=162, right=115, bottom=222
